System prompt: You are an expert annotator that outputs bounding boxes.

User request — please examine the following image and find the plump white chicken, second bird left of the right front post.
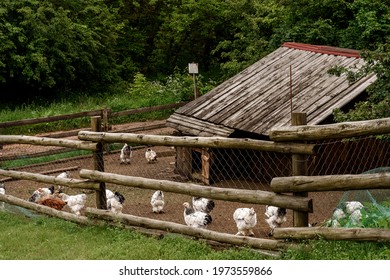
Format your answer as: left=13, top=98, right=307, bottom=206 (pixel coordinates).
left=233, top=208, right=257, bottom=236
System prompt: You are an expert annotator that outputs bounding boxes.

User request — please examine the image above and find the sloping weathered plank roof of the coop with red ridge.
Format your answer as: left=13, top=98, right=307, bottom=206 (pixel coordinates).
left=167, top=43, right=376, bottom=137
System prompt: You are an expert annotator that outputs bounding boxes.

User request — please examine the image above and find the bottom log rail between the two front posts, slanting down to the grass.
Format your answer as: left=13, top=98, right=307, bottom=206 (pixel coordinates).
left=85, top=207, right=294, bottom=250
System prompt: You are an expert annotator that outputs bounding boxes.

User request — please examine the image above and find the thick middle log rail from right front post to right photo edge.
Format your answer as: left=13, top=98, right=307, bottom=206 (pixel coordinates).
left=270, top=172, right=390, bottom=193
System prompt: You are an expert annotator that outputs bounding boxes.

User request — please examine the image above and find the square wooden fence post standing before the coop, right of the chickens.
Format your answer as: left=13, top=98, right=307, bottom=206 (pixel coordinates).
left=291, top=112, right=309, bottom=227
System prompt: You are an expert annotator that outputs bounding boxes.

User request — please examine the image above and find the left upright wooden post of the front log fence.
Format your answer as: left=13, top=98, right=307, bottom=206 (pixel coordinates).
left=91, top=116, right=107, bottom=209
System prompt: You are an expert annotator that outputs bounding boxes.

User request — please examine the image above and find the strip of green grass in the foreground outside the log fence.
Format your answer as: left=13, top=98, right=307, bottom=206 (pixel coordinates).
left=0, top=212, right=390, bottom=260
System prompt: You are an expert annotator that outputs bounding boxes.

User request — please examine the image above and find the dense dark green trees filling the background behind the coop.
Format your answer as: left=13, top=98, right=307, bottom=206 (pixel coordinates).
left=0, top=0, right=390, bottom=118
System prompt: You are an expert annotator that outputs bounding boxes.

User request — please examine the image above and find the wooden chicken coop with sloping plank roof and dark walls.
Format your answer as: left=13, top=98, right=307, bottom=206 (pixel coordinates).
left=167, top=43, right=390, bottom=184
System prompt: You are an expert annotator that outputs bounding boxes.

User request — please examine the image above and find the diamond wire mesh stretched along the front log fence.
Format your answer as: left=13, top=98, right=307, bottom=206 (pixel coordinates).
left=0, top=133, right=390, bottom=236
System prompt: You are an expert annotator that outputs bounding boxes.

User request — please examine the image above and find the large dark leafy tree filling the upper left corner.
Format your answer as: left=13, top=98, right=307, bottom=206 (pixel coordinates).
left=0, top=0, right=118, bottom=98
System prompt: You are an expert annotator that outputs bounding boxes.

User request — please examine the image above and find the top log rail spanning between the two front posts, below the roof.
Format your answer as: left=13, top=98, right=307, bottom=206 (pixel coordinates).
left=79, top=131, right=315, bottom=155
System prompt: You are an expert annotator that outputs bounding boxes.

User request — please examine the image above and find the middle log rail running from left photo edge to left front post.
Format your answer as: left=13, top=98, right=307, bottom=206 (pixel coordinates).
left=0, top=169, right=99, bottom=190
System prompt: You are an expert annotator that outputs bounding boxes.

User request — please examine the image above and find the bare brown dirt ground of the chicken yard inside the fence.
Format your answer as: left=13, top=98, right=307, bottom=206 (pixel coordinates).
left=0, top=122, right=342, bottom=238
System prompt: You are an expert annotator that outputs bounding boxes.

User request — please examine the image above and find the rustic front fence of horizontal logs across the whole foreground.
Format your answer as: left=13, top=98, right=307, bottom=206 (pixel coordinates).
left=0, top=114, right=390, bottom=250
